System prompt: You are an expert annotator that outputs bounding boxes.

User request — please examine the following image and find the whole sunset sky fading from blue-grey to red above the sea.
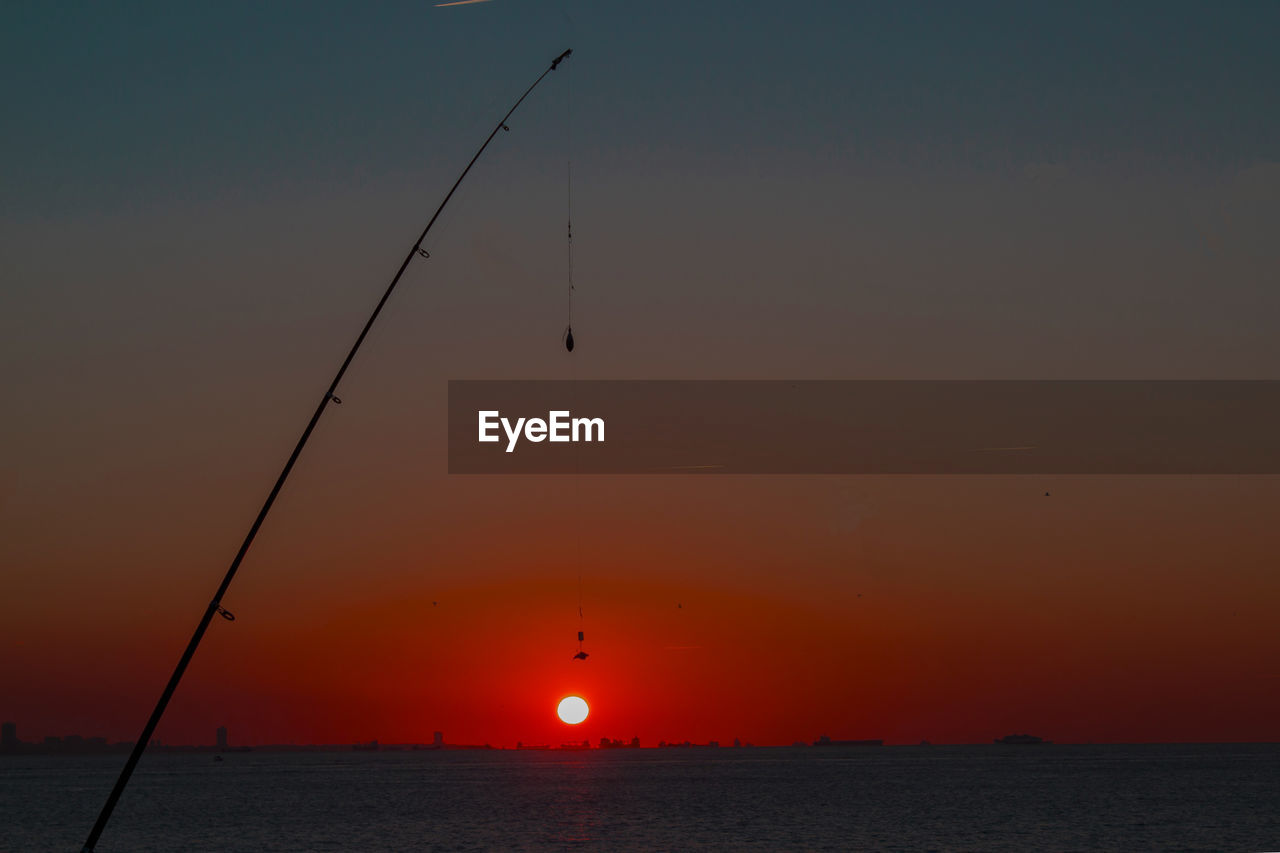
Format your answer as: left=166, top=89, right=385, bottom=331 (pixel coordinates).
left=0, top=0, right=1280, bottom=745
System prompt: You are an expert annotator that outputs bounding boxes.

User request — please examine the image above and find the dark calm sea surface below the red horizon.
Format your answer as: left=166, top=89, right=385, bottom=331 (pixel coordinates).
left=0, top=744, right=1280, bottom=853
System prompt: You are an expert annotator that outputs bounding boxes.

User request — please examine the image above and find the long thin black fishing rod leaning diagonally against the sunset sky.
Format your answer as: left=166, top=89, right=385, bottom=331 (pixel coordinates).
left=81, top=49, right=573, bottom=853
